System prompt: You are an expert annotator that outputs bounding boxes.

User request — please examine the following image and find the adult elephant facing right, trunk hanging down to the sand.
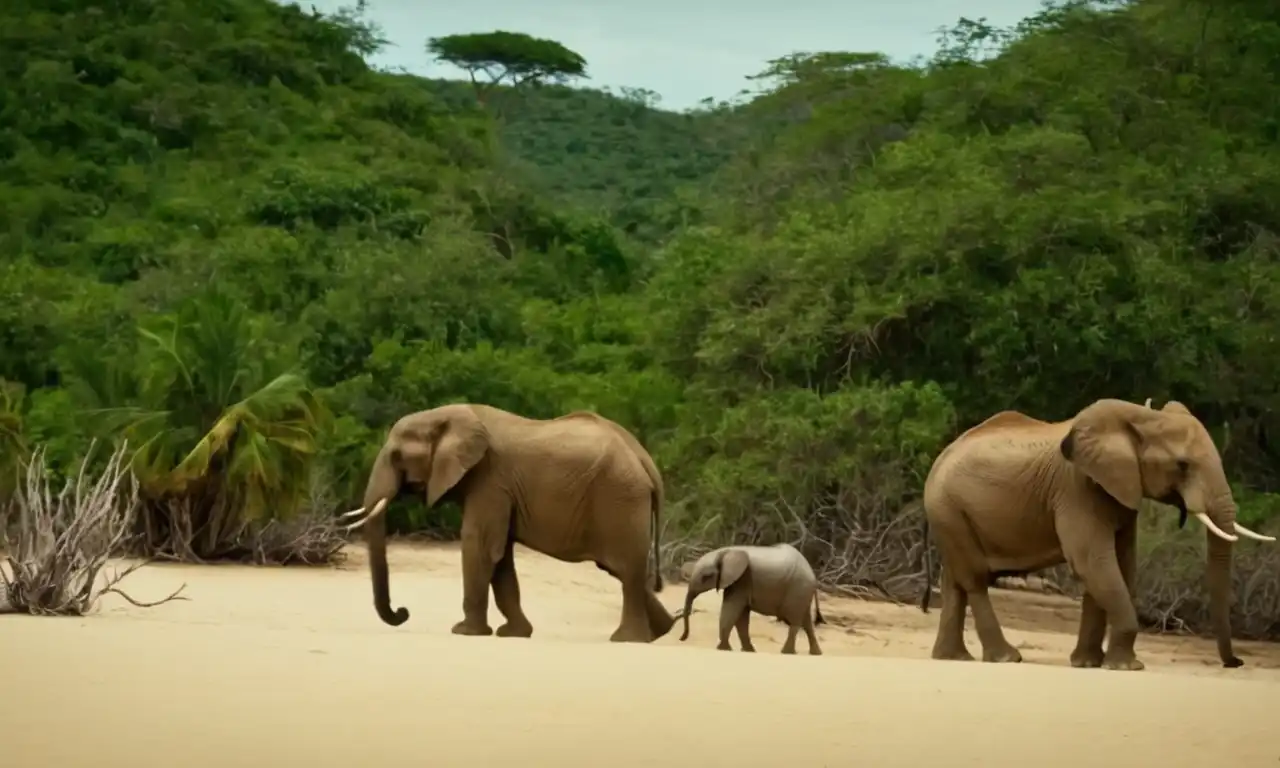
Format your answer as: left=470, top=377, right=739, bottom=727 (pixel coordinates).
left=920, top=399, right=1275, bottom=669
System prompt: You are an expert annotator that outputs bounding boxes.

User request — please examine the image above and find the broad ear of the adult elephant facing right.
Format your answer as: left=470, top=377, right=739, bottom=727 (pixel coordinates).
left=1060, top=401, right=1146, bottom=509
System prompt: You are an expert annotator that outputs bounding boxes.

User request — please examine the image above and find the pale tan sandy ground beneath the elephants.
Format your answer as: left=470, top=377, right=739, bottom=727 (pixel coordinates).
left=0, top=545, right=1280, bottom=768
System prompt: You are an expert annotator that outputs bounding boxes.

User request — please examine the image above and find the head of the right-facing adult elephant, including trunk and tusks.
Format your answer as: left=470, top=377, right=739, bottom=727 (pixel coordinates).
left=1060, top=399, right=1275, bottom=667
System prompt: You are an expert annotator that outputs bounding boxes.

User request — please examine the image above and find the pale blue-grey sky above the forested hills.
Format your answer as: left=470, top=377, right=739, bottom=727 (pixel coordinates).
left=307, top=0, right=1041, bottom=110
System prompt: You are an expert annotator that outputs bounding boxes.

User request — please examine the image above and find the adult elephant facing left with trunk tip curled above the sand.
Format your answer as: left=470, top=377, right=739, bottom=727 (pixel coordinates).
left=344, top=404, right=675, bottom=643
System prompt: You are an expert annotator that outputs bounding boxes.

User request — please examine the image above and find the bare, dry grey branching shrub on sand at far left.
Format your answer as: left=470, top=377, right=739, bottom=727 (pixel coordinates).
left=0, top=444, right=187, bottom=616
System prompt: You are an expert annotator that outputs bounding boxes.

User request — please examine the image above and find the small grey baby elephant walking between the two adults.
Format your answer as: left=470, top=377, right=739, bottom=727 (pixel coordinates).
left=680, top=544, right=826, bottom=655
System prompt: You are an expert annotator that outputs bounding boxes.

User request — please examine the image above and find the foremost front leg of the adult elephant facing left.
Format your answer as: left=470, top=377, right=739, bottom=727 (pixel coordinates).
left=452, top=488, right=515, bottom=636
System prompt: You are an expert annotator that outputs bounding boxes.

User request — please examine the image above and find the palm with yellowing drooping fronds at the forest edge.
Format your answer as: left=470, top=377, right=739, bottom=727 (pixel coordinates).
left=66, top=291, right=330, bottom=550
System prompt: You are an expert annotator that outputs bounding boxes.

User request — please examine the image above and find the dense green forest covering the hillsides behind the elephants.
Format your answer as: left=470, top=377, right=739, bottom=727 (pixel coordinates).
left=0, top=0, right=1280, bottom=637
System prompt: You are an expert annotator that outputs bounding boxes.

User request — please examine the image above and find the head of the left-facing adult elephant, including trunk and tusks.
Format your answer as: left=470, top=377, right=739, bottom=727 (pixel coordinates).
left=347, top=404, right=489, bottom=626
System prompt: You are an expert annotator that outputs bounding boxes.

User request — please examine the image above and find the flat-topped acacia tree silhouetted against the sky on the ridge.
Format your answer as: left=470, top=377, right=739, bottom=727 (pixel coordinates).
left=426, top=29, right=586, bottom=104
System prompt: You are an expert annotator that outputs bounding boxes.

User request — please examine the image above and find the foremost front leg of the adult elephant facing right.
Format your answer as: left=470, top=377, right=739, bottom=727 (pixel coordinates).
left=1068, top=531, right=1144, bottom=671
